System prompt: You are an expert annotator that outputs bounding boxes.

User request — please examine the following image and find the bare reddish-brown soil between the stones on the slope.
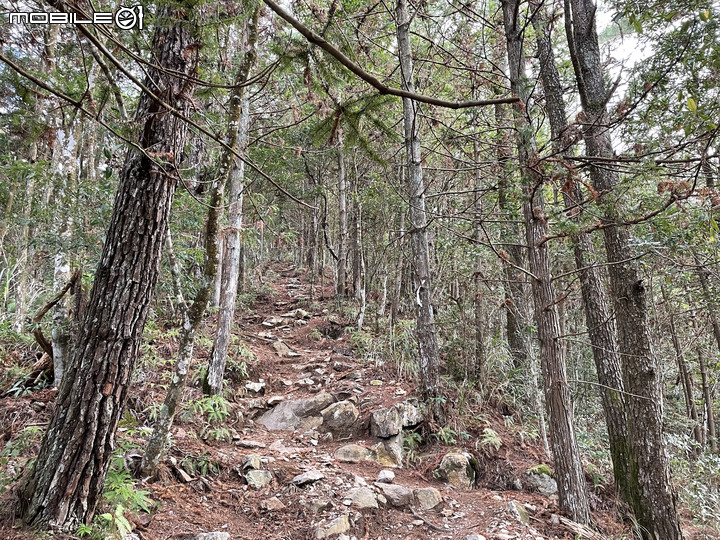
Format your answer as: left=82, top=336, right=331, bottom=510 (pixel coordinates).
left=0, top=266, right=700, bottom=540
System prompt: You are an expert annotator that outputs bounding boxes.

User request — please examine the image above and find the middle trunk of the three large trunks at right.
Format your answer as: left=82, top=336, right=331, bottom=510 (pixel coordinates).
left=533, top=1, right=637, bottom=510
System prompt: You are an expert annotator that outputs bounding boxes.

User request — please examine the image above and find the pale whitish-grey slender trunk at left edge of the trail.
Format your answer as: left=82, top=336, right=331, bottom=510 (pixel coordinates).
left=207, top=8, right=259, bottom=395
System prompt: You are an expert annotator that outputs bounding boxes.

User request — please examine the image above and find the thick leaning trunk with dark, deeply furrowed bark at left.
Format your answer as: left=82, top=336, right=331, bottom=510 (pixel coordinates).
left=19, top=7, right=197, bottom=530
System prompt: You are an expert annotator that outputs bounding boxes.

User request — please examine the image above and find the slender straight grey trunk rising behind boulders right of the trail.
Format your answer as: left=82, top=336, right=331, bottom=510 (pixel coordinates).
left=395, top=0, right=443, bottom=420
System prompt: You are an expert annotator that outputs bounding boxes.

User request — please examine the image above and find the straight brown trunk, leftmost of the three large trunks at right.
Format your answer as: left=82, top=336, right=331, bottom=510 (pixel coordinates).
left=502, top=0, right=590, bottom=524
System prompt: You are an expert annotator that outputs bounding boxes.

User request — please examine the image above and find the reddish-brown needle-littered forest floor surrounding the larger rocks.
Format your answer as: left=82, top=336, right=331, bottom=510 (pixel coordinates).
left=0, top=265, right=700, bottom=540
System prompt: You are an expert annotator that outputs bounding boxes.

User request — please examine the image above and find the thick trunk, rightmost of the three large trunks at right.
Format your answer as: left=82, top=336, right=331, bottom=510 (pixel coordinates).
left=565, top=0, right=683, bottom=540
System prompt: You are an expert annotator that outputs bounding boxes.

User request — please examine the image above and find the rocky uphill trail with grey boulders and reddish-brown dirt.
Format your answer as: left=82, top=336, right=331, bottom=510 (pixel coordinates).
left=0, top=266, right=622, bottom=540
